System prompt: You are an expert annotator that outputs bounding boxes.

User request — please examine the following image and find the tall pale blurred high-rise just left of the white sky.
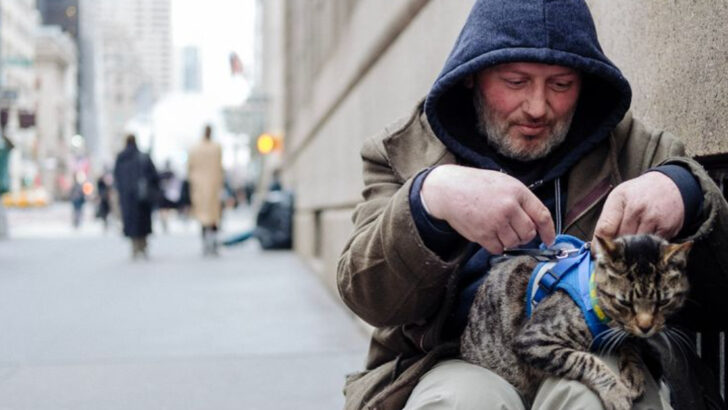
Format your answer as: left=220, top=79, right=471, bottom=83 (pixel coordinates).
left=79, top=0, right=172, bottom=164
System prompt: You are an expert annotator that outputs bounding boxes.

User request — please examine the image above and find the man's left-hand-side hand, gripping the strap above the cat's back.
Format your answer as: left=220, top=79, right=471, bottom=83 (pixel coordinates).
left=421, top=165, right=555, bottom=255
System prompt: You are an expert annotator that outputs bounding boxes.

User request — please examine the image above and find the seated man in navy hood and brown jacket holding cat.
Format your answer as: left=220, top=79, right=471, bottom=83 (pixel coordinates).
left=338, top=0, right=728, bottom=409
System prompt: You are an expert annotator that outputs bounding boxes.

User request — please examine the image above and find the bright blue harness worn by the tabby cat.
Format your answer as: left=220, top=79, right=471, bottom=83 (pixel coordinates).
left=526, top=235, right=609, bottom=348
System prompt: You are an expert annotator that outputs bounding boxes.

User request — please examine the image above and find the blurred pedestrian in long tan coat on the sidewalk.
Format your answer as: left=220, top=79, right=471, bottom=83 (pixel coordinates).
left=187, top=125, right=224, bottom=255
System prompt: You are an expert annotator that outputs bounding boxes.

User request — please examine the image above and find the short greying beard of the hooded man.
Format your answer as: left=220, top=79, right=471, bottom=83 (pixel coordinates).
left=473, top=87, right=576, bottom=161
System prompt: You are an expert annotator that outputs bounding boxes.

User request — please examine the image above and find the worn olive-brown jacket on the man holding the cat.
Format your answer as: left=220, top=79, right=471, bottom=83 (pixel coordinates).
left=337, top=106, right=728, bottom=409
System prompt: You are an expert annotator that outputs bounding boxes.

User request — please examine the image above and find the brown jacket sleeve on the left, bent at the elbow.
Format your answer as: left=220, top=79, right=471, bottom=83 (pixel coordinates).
left=337, top=139, right=462, bottom=327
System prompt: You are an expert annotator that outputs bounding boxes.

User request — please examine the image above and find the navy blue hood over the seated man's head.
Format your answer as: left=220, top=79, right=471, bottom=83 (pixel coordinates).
left=425, top=0, right=632, bottom=181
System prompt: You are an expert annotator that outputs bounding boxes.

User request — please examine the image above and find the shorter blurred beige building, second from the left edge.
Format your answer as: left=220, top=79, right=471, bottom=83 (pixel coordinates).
left=35, top=26, right=78, bottom=197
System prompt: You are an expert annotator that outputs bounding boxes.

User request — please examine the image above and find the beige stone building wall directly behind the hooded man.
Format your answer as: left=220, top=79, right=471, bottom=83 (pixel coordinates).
left=261, top=0, right=728, bottom=294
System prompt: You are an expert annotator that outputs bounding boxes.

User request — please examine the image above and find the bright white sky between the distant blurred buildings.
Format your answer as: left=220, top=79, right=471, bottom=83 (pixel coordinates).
left=146, top=0, right=255, bottom=175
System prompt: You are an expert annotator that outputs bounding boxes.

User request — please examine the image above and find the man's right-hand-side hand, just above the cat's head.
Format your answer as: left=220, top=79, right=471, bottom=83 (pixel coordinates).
left=594, top=172, right=685, bottom=239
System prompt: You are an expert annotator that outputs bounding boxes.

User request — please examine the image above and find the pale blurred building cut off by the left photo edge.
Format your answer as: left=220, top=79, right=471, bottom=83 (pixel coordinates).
left=0, top=0, right=40, bottom=190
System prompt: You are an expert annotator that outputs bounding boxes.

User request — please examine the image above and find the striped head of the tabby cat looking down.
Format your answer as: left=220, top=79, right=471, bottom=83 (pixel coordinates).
left=595, top=235, right=692, bottom=337
